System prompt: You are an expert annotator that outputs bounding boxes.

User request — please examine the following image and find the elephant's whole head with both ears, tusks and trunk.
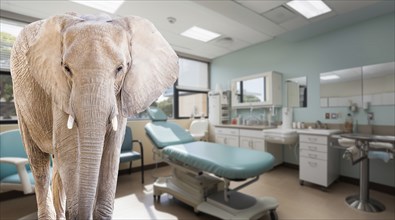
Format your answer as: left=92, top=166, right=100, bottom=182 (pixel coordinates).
left=26, top=15, right=178, bottom=218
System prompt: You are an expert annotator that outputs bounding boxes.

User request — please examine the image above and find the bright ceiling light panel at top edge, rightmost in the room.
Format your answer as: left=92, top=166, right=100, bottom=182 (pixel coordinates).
left=287, top=0, right=332, bottom=19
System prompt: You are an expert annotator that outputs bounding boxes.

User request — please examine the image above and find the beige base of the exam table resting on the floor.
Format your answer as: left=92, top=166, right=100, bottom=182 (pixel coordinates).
left=154, top=169, right=278, bottom=220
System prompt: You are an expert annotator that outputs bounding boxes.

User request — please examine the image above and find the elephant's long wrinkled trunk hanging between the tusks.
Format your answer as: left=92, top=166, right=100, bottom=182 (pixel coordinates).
left=72, top=78, right=118, bottom=219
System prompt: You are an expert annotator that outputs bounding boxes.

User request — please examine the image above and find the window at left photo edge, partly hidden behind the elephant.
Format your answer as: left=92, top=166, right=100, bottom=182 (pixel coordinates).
left=0, top=18, right=26, bottom=123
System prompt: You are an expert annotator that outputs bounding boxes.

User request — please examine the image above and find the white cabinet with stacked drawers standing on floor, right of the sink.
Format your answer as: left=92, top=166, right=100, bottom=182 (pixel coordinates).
left=299, top=134, right=339, bottom=187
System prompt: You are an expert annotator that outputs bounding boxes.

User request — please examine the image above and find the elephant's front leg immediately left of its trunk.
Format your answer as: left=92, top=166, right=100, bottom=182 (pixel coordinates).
left=53, top=107, right=79, bottom=219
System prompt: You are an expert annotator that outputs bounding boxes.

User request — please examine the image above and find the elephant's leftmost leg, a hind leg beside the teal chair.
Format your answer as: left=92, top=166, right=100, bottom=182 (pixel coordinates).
left=18, top=116, right=56, bottom=219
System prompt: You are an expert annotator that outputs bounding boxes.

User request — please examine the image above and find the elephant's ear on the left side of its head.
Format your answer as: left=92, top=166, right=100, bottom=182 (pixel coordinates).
left=26, top=15, right=82, bottom=114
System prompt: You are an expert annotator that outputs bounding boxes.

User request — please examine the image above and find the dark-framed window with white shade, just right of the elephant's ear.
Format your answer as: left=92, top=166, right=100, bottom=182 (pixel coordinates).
left=174, top=58, right=208, bottom=118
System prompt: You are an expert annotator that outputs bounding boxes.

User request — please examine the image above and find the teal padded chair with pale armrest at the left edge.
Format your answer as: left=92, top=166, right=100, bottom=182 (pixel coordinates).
left=0, top=129, right=34, bottom=194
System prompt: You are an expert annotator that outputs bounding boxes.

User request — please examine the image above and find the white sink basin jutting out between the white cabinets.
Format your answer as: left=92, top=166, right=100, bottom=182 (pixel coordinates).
left=263, top=128, right=298, bottom=144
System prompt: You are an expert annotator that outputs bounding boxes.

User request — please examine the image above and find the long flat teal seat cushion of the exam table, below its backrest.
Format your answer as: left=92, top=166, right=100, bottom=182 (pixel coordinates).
left=162, top=141, right=274, bottom=180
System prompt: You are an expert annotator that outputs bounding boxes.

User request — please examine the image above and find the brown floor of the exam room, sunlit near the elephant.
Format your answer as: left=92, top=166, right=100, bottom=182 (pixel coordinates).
left=0, top=167, right=395, bottom=220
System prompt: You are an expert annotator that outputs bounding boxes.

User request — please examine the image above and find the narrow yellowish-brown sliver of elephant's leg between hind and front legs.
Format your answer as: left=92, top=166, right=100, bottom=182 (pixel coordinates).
left=52, top=160, right=66, bottom=219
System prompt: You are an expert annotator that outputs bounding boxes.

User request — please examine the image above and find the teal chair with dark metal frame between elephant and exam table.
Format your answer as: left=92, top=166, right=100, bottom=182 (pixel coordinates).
left=120, top=126, right=144, bottom=183
